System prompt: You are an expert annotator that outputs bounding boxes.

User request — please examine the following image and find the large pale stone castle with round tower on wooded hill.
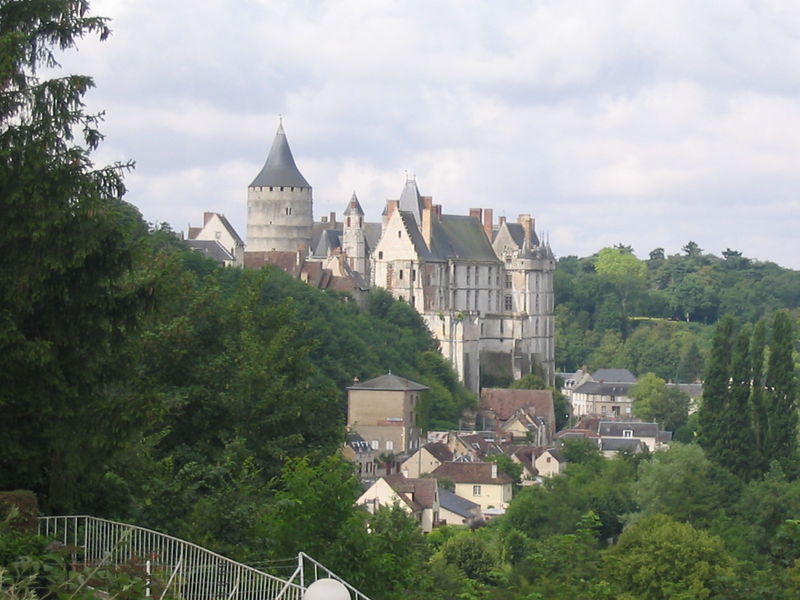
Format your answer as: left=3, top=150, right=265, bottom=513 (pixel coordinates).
left=244, top=124, right=555, bottom=392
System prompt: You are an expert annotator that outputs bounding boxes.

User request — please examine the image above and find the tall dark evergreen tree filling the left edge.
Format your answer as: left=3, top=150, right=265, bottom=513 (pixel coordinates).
left=0, top=0, right=151, bottom=510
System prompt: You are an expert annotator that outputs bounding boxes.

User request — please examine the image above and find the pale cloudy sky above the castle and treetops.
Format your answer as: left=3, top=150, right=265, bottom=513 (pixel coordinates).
left=62, top=0, right=800, bottom=269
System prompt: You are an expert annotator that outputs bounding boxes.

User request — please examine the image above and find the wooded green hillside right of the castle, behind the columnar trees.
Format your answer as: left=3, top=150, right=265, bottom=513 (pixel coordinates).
left=555, top=242, right=800, bottom=383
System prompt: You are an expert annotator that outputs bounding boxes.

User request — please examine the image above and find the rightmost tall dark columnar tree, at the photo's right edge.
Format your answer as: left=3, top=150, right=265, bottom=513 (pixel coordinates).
left=764, top=312, right=798, bottom=468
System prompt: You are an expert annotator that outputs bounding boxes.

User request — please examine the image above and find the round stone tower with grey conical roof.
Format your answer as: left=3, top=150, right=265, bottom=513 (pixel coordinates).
left=247, top=122, right=314, bottom=252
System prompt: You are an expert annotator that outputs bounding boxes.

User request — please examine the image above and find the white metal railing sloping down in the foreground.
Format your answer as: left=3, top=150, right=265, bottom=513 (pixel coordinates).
left=39, top=515, right=304, bottom=600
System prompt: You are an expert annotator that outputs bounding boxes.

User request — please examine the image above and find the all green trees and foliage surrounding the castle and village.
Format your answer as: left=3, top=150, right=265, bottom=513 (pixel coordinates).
left=0, top=0, right=800, bottom=600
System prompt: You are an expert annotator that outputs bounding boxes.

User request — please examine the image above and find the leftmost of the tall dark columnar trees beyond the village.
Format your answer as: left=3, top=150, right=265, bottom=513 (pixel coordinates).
left=697, top=315, right=734, bottom=462
